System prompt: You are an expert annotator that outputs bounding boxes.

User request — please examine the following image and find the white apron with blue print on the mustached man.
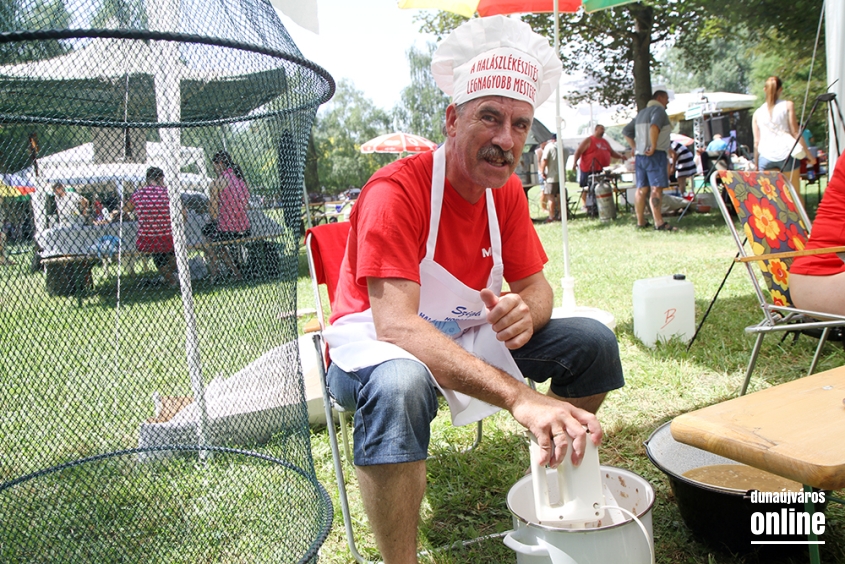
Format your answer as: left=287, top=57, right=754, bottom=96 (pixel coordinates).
left=324, top=147, right=525, bottom=426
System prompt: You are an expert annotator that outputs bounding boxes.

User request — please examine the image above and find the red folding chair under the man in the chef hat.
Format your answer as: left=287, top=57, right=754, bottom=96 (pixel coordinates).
left=305, top=221, right=483, bottom=564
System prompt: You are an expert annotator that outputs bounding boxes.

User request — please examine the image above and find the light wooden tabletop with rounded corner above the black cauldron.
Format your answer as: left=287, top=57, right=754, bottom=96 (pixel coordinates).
left=671, top=367, right=845, bottom=562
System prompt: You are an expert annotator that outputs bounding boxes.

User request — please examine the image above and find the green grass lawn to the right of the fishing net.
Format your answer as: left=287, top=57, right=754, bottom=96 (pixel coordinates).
left=299, top=183, right=845, bottom=564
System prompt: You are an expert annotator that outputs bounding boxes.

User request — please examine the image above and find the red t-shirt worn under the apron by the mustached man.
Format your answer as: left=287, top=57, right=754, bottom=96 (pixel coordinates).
left=331, top=152, right=548, bottom=322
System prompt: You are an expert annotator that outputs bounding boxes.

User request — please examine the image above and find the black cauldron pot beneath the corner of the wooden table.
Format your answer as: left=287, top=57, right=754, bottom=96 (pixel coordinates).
left=645, top=422, right=826, bottom=552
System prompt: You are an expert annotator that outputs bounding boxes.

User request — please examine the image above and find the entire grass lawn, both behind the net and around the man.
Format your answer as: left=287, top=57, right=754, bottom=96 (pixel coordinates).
left=0, top=180, right=845, bottom=564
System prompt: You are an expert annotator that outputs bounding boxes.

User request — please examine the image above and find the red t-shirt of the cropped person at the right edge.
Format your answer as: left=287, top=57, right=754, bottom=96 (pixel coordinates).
left=789, top=158, right=845, bottom=276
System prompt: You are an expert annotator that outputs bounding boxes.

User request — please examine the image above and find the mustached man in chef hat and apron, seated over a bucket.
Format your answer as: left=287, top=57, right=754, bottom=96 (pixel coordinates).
left=325, top=16, right=624, bottom=564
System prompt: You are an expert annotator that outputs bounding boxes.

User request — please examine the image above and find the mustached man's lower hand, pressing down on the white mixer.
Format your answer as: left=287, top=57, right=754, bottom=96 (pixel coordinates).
left=511, top=388, right=602, bottom=468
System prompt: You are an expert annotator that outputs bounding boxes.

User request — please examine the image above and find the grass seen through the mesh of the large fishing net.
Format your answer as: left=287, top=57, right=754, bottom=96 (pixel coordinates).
left=0, top=229, right=330, bottom=564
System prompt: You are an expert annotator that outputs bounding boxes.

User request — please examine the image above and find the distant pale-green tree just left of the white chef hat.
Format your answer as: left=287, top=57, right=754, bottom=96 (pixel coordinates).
left=394, top=43, right=450, bottom=143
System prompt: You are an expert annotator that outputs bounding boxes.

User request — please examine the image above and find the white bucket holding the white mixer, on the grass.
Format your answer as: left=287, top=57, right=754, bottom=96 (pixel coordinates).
left=504, top=466, right=654, bottom=564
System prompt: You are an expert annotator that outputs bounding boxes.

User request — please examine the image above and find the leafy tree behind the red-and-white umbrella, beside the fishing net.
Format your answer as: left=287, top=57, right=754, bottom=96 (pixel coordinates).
left=306, top=80, right=393, bottom=193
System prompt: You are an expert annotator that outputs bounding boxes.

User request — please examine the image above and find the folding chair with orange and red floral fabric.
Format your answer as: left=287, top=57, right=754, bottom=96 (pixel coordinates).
left=710, top=170, right=845, bottom=395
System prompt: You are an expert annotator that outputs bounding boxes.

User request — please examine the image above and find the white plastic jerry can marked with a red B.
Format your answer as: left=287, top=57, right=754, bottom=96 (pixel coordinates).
left=634, top=274, right=695, bottom=347
